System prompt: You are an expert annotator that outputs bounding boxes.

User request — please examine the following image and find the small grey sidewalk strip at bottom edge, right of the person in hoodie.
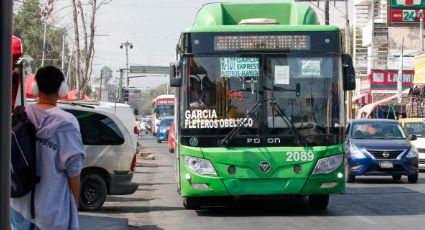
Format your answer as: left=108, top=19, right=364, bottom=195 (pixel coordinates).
left=79, top=213, right=128, bottom=230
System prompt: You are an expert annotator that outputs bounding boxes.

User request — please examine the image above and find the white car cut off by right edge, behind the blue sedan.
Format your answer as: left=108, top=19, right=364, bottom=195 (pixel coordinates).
left=399, top=118, right=425, bottom=170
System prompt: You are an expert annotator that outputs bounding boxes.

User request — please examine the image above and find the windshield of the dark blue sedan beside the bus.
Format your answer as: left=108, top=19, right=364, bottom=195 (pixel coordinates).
left=351, top=122, right=406, bottom=139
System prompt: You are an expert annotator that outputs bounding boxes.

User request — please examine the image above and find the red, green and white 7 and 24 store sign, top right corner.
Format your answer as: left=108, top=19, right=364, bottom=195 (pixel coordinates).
left=388, top=0, right=425, bottom=25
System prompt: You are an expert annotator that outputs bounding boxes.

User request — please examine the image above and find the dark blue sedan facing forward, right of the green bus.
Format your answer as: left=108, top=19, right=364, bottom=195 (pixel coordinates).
left=345, top=119, right=419, bottom=183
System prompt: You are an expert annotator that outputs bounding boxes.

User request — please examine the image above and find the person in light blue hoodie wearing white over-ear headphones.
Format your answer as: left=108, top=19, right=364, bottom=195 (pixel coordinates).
left=10, top=66, right=85, bottom=230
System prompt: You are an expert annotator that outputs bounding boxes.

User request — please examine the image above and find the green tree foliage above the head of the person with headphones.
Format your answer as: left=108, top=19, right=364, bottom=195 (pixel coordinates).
left=13, top=0, right=66, bottom=72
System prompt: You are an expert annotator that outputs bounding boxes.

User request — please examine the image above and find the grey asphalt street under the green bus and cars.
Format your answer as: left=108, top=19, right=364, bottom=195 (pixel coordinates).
left=80, top=135, right=425, bottom=230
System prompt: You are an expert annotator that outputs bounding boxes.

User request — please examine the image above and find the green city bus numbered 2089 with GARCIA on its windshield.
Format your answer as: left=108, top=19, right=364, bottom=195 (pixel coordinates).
left=170, top=3, right=355, bottom=209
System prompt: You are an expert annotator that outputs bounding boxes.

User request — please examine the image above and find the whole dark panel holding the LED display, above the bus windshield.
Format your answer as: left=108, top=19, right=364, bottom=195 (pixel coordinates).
left=187, top=31, right=341, bottom=54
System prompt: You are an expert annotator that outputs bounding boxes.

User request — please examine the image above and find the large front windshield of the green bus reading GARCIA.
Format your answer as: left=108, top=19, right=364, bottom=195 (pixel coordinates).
left=180, top=54, right=344, bottom=146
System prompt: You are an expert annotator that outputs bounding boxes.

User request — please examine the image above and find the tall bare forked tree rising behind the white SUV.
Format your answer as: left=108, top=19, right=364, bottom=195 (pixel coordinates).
left=71, top=0, right=112, bottom=95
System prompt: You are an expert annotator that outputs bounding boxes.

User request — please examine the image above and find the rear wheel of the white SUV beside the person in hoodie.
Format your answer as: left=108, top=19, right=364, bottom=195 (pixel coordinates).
left=78, top=174, right=108, bottom=211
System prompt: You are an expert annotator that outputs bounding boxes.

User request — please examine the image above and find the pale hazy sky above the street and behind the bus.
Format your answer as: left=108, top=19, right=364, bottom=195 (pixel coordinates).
left=50, top=0, right=353, bottom=89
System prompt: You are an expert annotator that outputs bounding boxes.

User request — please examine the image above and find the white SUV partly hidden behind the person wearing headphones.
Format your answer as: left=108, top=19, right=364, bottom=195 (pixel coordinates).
left=59, top=104, right=138, bottom=210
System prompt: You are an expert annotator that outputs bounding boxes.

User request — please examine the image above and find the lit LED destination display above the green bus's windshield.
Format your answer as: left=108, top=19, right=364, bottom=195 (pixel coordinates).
left=214, top=35, right=310, bottom=51
